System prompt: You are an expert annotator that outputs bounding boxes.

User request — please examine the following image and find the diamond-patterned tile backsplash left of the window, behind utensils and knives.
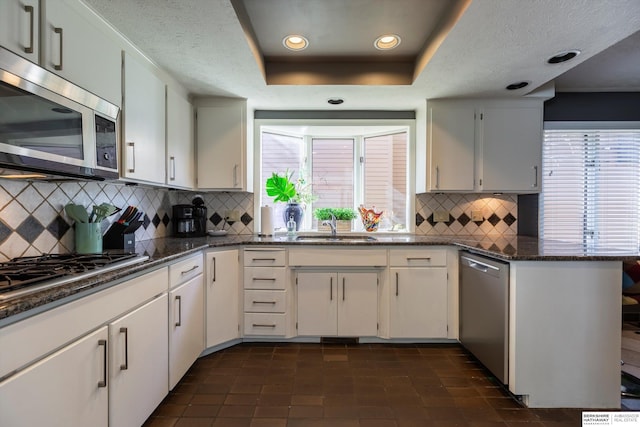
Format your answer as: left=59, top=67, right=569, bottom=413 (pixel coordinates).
left=0, top=179, right=253, bottom=261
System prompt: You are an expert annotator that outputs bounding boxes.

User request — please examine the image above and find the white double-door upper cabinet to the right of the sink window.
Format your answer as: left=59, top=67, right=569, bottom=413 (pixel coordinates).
left=427, top=99, right=542, bottom=193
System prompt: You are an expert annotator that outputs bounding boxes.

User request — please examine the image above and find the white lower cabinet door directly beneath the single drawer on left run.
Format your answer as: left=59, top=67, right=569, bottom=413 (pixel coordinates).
left=169, top=274, right=204, bottom=390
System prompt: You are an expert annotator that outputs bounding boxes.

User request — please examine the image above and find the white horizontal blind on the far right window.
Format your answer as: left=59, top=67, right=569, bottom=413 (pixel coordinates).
left=540, top=123, right=640, bottom=251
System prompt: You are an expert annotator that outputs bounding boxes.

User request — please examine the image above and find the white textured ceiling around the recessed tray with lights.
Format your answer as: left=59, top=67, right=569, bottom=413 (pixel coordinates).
left=83, top=0, right=640, bottom=110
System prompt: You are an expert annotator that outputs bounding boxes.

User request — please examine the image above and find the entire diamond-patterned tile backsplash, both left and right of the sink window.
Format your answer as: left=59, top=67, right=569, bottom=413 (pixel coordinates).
left=0, top=179, right=518, bottom=261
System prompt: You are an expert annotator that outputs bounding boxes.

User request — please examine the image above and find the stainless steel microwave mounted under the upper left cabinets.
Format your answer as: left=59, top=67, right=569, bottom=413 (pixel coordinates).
left=0, top=47, right=120, bottom=180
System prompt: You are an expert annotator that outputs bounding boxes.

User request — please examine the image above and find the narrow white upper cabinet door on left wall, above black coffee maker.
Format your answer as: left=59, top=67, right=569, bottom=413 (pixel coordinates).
left=166, top=86, right=195, bottom=188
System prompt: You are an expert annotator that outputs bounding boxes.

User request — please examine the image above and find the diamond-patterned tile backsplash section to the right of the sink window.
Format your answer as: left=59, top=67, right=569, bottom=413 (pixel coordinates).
left=416, top=193, right=518, bottom=236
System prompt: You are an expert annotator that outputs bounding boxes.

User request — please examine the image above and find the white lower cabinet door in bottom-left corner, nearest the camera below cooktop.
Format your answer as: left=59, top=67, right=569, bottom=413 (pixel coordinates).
left=0, top=326, right=109, bottom=427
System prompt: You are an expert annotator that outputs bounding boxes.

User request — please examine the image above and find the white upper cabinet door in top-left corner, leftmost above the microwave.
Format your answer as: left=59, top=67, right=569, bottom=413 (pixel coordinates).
left=0, top=0, right=40, bottom=62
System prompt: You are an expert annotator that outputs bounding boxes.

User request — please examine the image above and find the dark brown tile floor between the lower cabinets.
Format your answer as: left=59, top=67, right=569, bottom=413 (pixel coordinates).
left=144, top=343, right=624, bottom=427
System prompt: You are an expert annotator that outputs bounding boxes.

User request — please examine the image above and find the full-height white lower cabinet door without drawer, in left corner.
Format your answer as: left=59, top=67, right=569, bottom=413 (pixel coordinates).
left=205, top=249, right=240, bottom=348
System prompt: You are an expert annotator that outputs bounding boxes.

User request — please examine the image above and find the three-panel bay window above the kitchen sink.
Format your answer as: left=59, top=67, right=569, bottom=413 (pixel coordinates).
left=256, top=125, right=413, bottom=231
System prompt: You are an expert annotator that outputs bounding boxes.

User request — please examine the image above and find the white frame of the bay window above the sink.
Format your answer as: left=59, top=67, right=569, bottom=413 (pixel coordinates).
left=253, top=119, right=416, bottom=234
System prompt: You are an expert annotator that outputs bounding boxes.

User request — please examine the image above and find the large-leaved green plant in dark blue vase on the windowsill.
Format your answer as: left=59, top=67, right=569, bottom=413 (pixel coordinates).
left=265, top=169, right=315, bottom=230
